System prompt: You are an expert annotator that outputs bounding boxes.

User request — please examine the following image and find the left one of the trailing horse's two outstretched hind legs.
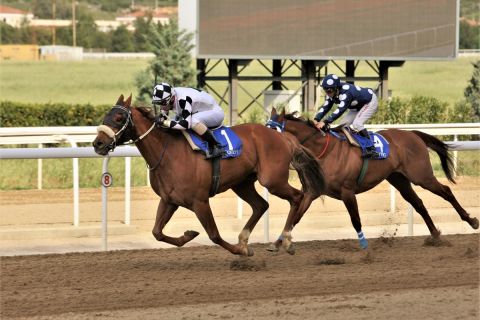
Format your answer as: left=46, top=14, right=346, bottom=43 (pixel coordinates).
left=387, top=173, right=440, bottom=238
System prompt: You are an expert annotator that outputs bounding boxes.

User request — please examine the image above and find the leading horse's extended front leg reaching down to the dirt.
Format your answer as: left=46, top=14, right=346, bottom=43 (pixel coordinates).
left=193, top=199, right=253, bottom=256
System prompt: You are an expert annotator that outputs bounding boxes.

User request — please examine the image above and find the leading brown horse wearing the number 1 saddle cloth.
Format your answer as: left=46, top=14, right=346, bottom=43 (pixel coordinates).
left=93, top=95, right=323, bottom=255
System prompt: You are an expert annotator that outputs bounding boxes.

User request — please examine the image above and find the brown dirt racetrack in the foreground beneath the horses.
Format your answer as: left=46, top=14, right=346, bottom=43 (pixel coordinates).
left=0, top=233, right=480, bottom=320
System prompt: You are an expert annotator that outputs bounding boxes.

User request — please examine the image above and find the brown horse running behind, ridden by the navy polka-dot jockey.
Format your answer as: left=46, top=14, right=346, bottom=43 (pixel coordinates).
left=267, top=108, right=479, bottom=248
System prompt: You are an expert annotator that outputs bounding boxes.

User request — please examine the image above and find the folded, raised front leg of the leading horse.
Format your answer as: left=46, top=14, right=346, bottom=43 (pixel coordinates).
left=152, top=199, right=198, bottom=247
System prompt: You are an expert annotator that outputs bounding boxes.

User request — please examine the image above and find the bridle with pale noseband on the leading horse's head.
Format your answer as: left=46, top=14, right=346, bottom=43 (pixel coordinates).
left=97, top=105, right=155, bottom=152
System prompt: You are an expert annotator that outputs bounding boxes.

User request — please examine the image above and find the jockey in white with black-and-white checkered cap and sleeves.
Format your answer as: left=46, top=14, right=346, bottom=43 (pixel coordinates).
left=152, top=83, right=225, bottom=159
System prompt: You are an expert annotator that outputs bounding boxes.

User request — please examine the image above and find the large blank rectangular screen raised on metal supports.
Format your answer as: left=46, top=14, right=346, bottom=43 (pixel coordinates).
left=196, top=0, right=459, bottom=60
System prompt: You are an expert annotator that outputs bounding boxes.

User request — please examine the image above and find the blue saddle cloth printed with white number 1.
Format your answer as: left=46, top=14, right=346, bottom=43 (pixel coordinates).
left=187, top=126, right=242, bottom=159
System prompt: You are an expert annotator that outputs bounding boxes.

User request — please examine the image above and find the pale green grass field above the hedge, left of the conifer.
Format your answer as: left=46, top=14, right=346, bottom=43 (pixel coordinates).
left=0, top=60, right=148, bottom=105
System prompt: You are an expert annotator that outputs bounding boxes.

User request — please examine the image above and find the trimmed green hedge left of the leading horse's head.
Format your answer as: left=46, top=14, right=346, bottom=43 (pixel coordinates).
left=0, top=101, right=111, bottom=127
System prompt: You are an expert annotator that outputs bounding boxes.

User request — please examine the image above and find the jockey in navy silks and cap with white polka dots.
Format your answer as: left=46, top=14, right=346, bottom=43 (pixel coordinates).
left=313, top=74, right=378, bottom=158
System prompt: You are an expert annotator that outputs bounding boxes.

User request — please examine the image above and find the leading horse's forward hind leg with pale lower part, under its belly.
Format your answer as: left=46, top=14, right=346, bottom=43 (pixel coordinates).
left=232, top=181, right=269, bottom=256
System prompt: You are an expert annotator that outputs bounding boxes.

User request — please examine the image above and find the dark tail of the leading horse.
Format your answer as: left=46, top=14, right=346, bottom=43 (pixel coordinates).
left=292, top=145, right=325, bottom=198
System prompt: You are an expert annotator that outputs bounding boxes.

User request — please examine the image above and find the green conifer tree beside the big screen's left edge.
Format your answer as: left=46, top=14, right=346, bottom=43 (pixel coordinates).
left=135, top=19, right=196, bottom=102
